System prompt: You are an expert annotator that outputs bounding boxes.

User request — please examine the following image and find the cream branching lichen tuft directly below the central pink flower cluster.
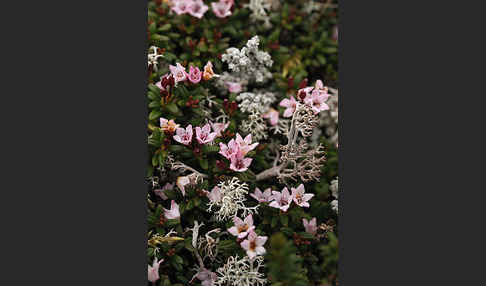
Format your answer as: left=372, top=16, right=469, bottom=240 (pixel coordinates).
left=208, top=177, right=258, bottom=221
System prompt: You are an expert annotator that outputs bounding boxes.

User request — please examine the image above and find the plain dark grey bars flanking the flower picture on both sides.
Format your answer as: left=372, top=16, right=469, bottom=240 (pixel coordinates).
left=0, top=0, right=484, bottom=285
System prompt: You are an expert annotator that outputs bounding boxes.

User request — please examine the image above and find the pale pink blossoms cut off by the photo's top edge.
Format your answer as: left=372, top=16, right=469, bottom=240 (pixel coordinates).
left=171, top=0, right=234, bottom=19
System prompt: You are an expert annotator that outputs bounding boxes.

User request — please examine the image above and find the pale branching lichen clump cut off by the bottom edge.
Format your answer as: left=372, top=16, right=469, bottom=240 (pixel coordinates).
left=213, top=256, right=267, bottom=286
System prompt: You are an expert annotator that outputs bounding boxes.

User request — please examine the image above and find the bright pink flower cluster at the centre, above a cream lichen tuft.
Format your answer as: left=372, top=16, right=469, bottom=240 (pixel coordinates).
left=219, top=133, right=258, bottom=172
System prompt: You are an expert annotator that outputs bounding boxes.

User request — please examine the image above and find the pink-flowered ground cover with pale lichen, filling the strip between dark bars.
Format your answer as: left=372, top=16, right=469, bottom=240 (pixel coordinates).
left=147, top=0, right=339, bottom=286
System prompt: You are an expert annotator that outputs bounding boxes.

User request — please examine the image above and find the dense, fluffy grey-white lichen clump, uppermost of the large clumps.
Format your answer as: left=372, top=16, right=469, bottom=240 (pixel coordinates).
left=221, top=36, right=273, bottom=82
